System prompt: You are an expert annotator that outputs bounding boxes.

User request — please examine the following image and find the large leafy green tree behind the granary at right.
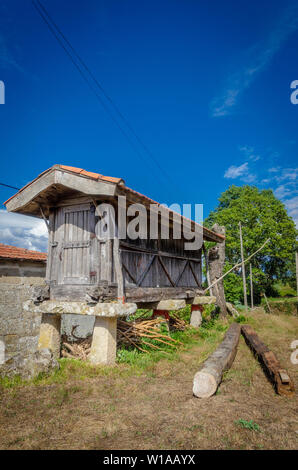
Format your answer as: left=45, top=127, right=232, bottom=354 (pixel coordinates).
left=205, top=185, right=298, bottom=301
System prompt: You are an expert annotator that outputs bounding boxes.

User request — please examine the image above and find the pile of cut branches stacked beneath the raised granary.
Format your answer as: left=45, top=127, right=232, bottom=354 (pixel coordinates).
left=117, top=317, right=186, bottom=353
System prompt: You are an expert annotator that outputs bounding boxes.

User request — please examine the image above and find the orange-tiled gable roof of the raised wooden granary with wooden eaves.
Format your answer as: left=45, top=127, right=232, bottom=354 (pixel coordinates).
left=4, top=165, right=225, bottom=242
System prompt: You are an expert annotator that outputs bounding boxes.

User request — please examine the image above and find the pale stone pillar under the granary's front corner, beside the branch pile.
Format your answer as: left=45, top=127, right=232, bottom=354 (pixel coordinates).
left=89, top=317, right=117, bottom=365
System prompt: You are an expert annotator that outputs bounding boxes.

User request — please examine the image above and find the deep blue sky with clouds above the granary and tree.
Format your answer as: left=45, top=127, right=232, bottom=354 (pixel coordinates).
left=0, top=0, right=298, bottom=249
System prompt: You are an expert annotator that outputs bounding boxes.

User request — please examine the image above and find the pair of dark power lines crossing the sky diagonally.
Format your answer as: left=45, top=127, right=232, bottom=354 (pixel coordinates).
left=32, top=0, right=177, bottom=189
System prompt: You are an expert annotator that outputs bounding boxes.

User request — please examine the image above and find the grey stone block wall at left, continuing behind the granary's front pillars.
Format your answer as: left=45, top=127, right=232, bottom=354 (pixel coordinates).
left=0, top=260, right=94, bottom=378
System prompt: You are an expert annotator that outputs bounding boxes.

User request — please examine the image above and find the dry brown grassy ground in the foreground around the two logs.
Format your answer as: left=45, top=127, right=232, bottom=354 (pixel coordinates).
left=0, top=310, right=298, bottom=450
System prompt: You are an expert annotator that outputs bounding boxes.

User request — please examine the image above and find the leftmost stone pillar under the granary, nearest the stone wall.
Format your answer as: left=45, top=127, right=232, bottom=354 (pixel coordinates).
left=38, top=313, right=61, bottom=359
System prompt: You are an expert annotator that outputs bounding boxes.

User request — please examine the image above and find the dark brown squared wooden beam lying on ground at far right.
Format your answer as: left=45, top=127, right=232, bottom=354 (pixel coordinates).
left=241, top=325, right=295, bottom=396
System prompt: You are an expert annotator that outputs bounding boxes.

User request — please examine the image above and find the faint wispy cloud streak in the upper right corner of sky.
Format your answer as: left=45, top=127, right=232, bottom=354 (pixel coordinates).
left=210, top=3, right=298, bottom=117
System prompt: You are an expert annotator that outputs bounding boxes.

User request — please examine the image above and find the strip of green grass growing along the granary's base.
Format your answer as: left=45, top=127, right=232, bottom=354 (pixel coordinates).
left=0, top=306, right=229, bottom=389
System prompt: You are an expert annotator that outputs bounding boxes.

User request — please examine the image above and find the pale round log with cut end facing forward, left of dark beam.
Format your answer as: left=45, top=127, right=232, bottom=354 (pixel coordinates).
left=193, top=323, right=240, bottom=398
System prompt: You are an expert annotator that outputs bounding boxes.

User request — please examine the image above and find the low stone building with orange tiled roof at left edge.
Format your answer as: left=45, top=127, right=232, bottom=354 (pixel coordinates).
left=0, top=243, right=47, bottom=375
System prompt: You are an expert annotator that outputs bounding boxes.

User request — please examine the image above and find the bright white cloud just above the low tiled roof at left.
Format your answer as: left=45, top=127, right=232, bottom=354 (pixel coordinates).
left=0, top=209, right=48, bottom=252
